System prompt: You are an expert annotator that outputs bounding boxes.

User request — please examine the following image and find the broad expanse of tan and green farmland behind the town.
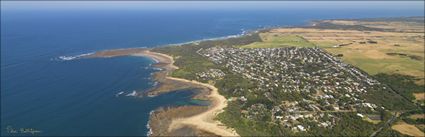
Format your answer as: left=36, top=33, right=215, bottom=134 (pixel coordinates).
left=269, top=27, right=425, bottom=79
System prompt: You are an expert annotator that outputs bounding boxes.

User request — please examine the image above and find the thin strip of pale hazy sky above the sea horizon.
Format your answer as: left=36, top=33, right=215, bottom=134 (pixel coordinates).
left=1, top=1, right=424, bottom=10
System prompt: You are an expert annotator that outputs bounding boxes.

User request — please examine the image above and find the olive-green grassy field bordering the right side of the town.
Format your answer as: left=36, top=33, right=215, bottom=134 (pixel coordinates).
left=324, top=47, right=425, bottom=82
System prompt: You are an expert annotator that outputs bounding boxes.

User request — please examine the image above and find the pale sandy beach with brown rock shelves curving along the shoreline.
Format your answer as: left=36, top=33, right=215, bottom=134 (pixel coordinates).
left=87, top=49, right=239, bottom=136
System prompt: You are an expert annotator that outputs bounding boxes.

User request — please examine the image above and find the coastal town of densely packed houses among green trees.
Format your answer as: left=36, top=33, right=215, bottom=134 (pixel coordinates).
left=197, top=47, right=389, bottom=132
